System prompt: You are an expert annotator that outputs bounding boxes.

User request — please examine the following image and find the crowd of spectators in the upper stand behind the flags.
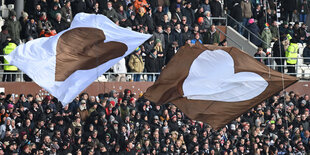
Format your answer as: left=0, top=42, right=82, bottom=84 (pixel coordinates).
left=0, top=0, right=310, bottom=81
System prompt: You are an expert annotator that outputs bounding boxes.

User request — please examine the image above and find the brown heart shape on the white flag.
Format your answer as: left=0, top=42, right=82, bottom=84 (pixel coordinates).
left=55, top=28, right=128, bottom=81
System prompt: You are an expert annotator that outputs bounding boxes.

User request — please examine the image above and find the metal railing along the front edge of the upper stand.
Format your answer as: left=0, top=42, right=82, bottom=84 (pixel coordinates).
left=0, top=57, right=310, bottom=82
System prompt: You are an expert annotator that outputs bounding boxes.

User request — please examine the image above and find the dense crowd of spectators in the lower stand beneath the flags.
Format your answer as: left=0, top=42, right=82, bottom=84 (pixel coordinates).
left=0, top=89, right=310, bottom=155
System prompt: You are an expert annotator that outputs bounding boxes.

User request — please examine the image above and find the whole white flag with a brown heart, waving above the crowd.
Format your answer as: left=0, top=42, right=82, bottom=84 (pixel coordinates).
left=5, top=13, right=151, bottom=105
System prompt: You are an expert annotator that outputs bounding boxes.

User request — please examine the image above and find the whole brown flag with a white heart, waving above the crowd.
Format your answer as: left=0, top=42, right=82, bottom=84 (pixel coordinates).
left=144, top=43, right=297, bottom=130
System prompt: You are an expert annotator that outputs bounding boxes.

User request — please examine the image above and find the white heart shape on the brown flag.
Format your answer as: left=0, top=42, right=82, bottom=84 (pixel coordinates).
left=183, top=50, right=268, bottom=102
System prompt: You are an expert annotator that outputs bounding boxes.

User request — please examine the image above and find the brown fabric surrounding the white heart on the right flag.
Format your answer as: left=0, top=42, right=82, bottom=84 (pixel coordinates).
left=144, top=43, right=297, bottom=130
